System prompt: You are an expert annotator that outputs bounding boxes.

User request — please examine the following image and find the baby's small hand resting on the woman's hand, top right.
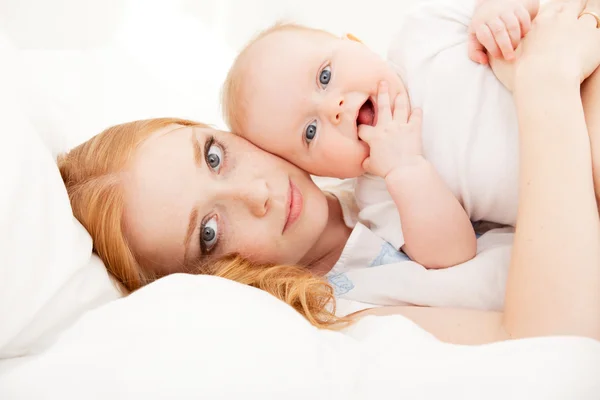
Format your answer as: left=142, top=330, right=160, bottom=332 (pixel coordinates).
left=469, top=0, right=537, bottom=64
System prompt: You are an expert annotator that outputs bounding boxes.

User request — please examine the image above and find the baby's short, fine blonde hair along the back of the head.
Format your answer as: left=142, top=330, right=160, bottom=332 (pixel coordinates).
left=221, top=21, right=335, bottom=134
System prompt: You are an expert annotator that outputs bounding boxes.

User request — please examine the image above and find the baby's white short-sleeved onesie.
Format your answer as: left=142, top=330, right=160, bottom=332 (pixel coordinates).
left=356, top=0, right=519, bottom=248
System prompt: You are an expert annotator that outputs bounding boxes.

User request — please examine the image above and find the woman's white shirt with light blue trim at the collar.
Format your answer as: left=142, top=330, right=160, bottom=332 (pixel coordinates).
left=323, top=181, right=513, bottom=315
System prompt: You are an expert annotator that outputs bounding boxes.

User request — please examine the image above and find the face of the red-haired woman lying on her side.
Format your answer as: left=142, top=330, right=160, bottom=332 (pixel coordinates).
left=124, top=125, right=328, bottom=274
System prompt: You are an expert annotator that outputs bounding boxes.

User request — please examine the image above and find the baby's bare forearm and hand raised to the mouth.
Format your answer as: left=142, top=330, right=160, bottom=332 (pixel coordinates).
left=359, top=81, right=476, bottom=268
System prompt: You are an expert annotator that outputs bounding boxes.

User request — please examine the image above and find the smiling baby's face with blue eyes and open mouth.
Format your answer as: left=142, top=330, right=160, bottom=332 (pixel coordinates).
left=239, top=29, right=403, bottom=178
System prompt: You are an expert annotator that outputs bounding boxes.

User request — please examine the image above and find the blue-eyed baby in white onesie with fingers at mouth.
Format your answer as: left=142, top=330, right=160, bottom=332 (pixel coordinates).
left=223, top=0, right=538, bottom=268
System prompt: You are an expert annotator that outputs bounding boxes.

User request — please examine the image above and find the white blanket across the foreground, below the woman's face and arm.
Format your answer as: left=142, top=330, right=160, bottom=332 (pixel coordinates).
left=0, top=275, right=600, bottom=400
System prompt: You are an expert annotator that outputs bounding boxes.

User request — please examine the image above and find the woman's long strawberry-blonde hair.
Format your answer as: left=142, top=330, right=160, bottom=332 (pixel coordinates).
left=58, top=118, right=347, bottom=328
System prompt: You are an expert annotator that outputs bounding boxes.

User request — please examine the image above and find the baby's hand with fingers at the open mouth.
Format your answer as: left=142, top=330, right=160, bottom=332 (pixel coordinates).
left=358, top=82, right=423, bottom=178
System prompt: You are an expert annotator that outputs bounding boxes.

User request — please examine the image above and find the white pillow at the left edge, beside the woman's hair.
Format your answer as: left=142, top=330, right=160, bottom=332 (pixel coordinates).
left=0, top=35, right=120, bottom=359
